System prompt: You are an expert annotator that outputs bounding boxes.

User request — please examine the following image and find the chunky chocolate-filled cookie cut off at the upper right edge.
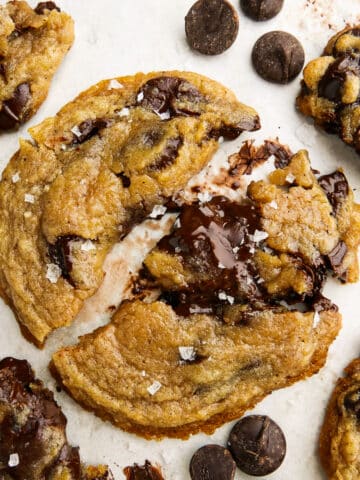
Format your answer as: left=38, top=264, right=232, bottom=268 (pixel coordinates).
left=296, top=26, right=360, bottom=154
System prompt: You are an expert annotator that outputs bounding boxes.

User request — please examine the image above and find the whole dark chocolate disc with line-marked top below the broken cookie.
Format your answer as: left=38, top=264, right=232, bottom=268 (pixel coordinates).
left=228, top=415, right=286, bottom=476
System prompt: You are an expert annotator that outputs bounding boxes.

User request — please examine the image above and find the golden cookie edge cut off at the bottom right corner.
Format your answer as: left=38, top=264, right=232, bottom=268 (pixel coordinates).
left=319, top=359, right=360, bottom=480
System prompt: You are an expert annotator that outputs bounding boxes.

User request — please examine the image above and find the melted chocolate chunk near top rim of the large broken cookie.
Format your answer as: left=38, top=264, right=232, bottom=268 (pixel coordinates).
left=137, top=77, right=205, bottom=118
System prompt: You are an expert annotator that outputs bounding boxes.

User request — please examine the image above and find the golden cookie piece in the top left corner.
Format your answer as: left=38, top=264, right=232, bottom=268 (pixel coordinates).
left=0, top=0, right=74, bottom=130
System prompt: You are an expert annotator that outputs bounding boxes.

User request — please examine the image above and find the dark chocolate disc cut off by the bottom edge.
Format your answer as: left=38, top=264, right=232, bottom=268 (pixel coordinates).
left=190, top=445, right=236, bottom=480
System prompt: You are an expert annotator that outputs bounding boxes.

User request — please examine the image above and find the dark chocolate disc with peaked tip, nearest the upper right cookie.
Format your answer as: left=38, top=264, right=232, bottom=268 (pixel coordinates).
left=252, top=31, right=305, bottom=83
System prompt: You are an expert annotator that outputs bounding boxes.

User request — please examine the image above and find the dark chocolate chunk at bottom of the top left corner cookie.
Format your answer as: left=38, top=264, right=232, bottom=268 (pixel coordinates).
left=0, top=83, right=31, bottom=130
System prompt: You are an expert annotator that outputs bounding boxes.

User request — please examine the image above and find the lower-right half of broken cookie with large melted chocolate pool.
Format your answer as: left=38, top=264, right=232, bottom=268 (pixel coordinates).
left=52, top=151, right=360, bottom=438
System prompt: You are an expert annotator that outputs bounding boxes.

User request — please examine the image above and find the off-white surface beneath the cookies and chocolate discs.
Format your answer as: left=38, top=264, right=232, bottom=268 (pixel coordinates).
left=0, top=0, right=360, bottom=480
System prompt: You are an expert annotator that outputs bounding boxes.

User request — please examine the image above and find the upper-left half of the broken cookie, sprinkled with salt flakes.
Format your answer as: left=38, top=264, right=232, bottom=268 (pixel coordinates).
left=0, top=72, right=259, bottom=344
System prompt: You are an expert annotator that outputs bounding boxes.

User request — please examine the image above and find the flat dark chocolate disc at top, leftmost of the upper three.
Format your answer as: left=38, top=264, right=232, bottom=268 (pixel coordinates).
left=185, top=0, right=239, bottom=55
